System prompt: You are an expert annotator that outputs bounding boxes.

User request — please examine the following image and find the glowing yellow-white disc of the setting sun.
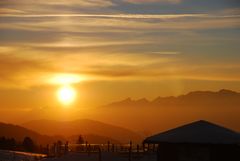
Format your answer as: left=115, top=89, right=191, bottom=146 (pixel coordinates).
left=57, top=86, right=76, bottom=105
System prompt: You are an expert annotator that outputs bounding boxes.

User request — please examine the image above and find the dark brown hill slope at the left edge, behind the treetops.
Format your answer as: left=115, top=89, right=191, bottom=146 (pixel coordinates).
left=0, top=123, right=60, bottom=145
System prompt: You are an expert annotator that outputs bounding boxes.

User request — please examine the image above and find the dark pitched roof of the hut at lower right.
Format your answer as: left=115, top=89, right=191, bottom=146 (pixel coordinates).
left=144, top=120, right=240, bottom=144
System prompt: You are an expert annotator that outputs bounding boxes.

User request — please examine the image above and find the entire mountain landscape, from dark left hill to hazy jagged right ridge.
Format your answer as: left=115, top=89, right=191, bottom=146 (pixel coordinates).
left=0, top=89, right=240, bottom=144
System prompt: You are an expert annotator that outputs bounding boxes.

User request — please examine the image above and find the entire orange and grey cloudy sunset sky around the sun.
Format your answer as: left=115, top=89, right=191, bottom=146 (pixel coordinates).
left=0, top=0, right=240, bottom=124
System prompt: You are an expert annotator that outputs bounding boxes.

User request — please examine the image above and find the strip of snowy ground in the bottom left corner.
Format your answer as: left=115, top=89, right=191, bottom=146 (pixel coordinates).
left=0, top=150, right=45, bottom=161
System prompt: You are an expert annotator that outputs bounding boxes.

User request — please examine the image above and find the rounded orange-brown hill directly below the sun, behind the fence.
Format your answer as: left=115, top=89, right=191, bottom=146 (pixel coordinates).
left=22, top=119, right=142, bottom=143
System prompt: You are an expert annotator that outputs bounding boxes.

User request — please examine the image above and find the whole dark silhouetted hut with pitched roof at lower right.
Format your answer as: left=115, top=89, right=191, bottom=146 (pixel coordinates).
left=144, top=120, right=240, bottom=161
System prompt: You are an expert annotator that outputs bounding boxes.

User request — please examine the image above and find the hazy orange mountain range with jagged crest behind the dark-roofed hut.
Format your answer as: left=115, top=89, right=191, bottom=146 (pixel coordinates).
left=98, top=89, right=240, bottom=136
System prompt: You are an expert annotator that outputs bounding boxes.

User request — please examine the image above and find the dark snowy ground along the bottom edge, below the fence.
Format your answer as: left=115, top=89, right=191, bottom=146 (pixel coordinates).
left=43, top=152, right=157, bottom=161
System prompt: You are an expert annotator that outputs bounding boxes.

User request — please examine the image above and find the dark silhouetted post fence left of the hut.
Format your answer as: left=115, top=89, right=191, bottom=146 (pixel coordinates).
left=47, top=141, right=157, bottom=161
